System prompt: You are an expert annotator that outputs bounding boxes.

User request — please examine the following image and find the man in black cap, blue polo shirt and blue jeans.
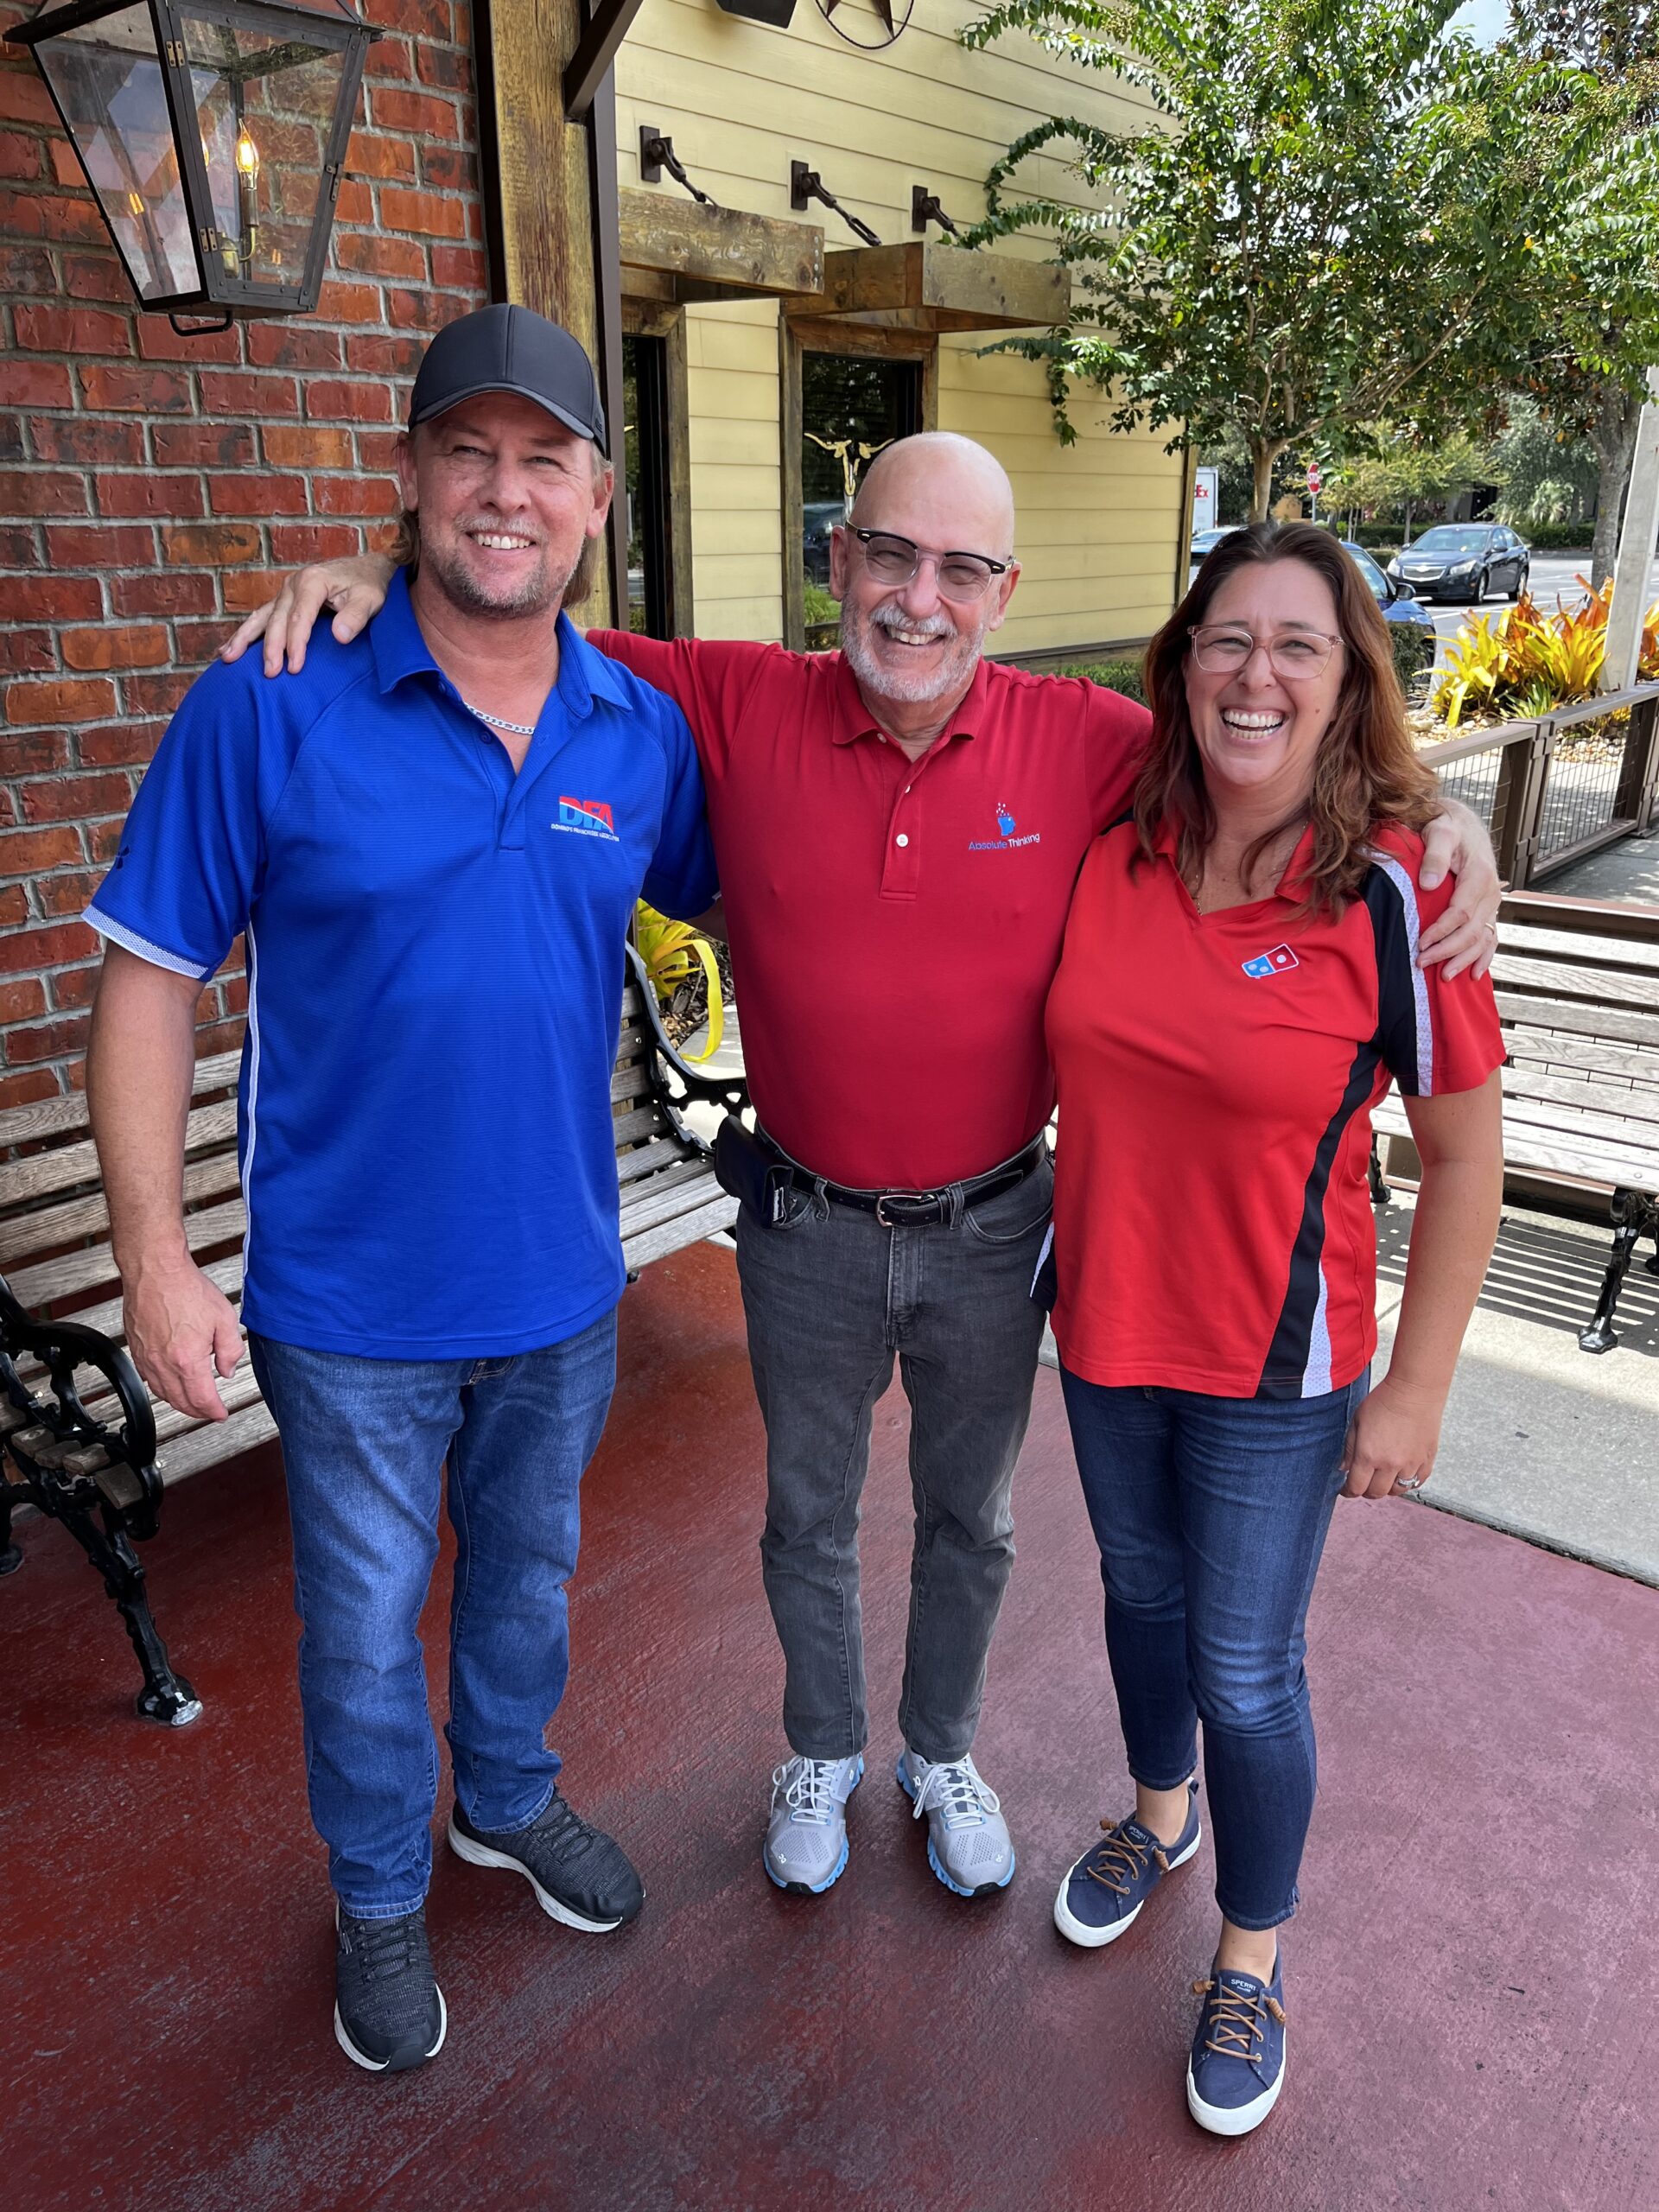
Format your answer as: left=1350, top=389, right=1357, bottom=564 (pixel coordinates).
left=86, top=308, right=715, bottom=2070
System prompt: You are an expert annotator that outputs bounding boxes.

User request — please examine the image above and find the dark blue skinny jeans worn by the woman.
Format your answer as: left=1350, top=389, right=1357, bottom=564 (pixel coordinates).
left=1062, top=1370, right=1370, bottom=1929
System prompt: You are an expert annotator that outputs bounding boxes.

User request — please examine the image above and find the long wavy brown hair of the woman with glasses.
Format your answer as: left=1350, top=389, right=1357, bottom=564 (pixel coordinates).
left=1135, top=522, right=1440, bottom=916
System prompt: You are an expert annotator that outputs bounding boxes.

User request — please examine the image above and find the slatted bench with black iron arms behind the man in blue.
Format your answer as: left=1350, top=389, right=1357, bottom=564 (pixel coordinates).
left=0, top=949, right=746, bottom=1727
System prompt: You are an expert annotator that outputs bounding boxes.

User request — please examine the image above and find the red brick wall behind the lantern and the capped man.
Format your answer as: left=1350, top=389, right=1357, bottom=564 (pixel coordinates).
left=0, top=0, right=485, bottom=1106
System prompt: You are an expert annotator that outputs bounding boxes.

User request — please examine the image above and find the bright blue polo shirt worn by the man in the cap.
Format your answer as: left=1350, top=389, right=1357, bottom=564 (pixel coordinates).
left=86, top=575, right=716, bottom=1360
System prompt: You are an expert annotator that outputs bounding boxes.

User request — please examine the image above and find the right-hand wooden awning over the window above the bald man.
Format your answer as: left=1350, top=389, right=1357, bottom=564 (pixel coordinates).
left=785, top=238, right=1071, bottom=329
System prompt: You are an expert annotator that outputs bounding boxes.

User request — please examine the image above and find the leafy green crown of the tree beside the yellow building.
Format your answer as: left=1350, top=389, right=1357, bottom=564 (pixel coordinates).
left=963, top=0, right=1659, bottom=515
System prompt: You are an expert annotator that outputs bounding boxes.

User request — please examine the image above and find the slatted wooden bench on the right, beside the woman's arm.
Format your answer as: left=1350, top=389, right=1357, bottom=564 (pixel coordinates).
left=1374, top=892, right=1659, bottom=1351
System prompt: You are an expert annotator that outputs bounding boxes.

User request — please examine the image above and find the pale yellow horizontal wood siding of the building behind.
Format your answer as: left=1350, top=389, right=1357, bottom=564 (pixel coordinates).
left=617, top=0, right=1185, bottom=652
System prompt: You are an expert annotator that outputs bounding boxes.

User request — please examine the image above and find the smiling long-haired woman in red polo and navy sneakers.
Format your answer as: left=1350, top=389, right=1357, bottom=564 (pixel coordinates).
left=1048, top=524, right=1504, bottom=2134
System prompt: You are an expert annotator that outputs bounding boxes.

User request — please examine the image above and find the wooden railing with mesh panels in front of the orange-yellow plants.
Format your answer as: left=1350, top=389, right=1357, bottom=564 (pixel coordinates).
left=1421, top=683, right=1659, bottom=892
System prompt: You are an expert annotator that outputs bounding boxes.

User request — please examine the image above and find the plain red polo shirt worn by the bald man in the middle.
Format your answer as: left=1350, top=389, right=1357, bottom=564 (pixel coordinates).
left=593, top=631, right=1150, bottom=1190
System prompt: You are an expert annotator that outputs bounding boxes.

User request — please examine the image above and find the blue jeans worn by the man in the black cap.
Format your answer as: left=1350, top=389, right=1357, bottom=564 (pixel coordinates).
left=250, top=1314, right=617, bottom=1920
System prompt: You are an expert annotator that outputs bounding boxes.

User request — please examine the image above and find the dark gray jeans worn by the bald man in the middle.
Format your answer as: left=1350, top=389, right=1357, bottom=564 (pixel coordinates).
left=736, top=1161, right=1053, bottom=1758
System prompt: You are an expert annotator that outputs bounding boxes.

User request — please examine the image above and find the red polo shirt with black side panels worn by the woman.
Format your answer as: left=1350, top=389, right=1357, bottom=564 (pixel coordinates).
left=1048, top=823, right=1504, bottom=1398
